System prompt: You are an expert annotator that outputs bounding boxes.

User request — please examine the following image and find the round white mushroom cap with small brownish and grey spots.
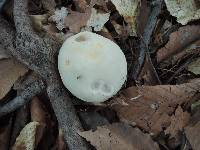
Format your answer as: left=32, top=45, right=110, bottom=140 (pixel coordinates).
left=58, top=32, right=127, bottom=103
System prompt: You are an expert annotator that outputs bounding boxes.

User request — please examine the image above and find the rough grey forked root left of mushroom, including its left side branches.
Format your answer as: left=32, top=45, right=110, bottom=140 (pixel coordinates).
left=0, top=0, right=87, bottom=150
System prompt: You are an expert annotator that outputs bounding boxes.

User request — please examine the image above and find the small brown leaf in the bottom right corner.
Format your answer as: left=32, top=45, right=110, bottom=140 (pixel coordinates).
left=185, top=122, right=200, bottom=150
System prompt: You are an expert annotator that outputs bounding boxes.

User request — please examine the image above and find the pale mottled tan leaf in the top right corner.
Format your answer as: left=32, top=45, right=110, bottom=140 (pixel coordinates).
left=165, top=0, right=200, bottom=25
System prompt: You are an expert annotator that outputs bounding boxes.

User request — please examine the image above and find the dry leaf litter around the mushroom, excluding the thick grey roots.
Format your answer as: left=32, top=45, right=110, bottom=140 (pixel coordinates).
left=0, top=0, right=200, bottom=150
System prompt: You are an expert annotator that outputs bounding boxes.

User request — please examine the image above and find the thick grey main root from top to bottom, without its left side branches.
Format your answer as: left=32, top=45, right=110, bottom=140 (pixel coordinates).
left=11, top=0, right=86, bottom=150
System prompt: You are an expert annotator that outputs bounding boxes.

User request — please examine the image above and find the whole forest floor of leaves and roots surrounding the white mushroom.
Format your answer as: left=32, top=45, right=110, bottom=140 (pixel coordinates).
left=0, top=0, right=200, bottom=150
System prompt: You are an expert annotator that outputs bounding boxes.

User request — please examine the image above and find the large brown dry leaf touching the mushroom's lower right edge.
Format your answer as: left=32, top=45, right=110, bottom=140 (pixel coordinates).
left=111, top=79, right=200, bottom=134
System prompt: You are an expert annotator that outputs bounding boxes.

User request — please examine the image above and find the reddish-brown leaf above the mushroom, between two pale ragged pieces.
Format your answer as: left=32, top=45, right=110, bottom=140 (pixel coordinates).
left=65, top=8, right=91, bottom=33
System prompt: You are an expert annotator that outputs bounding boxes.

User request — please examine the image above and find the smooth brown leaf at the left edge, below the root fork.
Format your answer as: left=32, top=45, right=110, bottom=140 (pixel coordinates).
left=0, top=59, right=28, bottom=99
